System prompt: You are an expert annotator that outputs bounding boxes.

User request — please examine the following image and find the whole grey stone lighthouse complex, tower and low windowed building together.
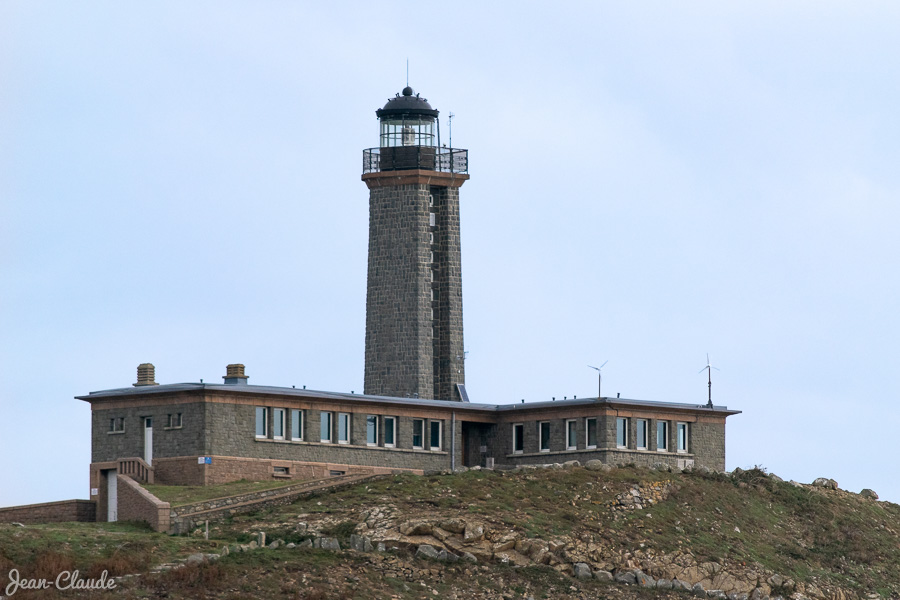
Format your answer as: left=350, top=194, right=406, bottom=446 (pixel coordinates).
left=78, top=87, right=739, bottom=520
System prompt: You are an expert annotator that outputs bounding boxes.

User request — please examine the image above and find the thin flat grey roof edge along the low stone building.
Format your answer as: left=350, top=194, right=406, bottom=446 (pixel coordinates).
left=75, top=383, right=741, bottom=416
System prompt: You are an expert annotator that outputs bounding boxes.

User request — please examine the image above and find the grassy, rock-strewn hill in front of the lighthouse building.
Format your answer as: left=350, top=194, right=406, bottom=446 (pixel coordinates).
left=0, top=467, right=900, bottom=599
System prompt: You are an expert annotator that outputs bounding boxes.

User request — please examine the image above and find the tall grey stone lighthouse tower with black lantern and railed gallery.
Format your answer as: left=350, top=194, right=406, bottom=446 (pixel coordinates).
left=362, top=87, right=469, bottom=401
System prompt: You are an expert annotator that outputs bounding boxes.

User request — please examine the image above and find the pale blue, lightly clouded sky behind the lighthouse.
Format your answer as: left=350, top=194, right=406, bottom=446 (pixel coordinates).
left=0, top=0, right=900, bottom=506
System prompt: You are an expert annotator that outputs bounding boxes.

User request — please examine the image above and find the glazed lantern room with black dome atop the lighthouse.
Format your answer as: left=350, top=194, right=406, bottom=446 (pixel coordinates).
left=375, top=86, right=438, bottom=148
